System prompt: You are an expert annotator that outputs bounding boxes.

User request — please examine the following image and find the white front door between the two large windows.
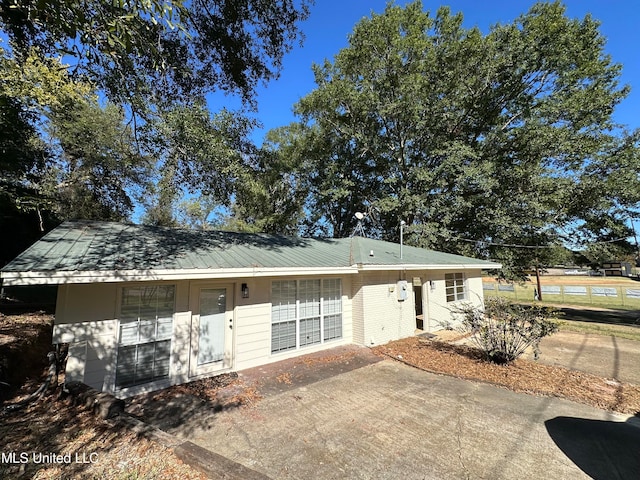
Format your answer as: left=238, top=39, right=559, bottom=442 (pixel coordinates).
left=189, top=284, right=233, bottom=377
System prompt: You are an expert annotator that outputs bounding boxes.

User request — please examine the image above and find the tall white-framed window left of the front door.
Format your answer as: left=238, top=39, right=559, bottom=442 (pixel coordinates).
left=116, top=285, right=175, bottom=388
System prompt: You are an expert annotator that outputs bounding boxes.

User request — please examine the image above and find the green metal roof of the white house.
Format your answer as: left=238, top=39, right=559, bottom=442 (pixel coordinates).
left=0, top=221, right=499, bottom=285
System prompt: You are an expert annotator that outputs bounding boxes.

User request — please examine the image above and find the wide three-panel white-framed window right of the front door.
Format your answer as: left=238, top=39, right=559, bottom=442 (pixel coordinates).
left=271, top=278, right=342, bottom=353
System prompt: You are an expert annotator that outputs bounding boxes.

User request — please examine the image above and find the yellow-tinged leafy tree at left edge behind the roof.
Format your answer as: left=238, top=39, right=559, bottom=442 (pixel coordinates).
left=0, top=46, right=150, bottom=223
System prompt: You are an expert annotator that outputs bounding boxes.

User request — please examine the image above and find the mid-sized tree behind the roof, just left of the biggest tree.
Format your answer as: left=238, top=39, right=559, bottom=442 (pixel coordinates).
left=141, top=102, right=255, bottom=226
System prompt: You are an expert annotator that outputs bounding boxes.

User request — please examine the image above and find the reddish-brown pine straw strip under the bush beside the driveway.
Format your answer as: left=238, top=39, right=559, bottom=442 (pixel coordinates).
left=373, top=337, right=640, bottom=415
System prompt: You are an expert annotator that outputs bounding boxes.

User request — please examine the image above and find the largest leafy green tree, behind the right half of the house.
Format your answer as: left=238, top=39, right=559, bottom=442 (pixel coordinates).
left=297, top=1, right=637, bottom=277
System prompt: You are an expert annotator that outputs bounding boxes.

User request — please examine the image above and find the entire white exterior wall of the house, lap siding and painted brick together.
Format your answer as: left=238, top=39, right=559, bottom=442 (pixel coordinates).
left=53, top=270, right=483, bottom=395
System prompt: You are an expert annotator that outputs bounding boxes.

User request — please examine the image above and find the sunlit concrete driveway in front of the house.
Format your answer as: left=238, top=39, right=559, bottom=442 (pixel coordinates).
left=164, top=356, right=640, bottom=479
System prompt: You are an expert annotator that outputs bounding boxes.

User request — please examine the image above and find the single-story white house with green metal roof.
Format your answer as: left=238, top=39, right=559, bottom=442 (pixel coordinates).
left=0, top=221, right=500, bottom=397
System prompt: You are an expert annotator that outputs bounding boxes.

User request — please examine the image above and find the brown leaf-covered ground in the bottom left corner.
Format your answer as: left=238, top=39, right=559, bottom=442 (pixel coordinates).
left=0, top=388, right=206, bottom=480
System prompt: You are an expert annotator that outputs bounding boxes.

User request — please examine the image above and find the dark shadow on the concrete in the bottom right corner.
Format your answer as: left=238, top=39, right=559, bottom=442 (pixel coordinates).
left=545, top=417, right=640, bottom=480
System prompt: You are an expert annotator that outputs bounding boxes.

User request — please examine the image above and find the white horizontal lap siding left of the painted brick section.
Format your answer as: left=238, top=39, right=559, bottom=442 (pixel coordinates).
left=53, top=276, right=353, bottom=397
